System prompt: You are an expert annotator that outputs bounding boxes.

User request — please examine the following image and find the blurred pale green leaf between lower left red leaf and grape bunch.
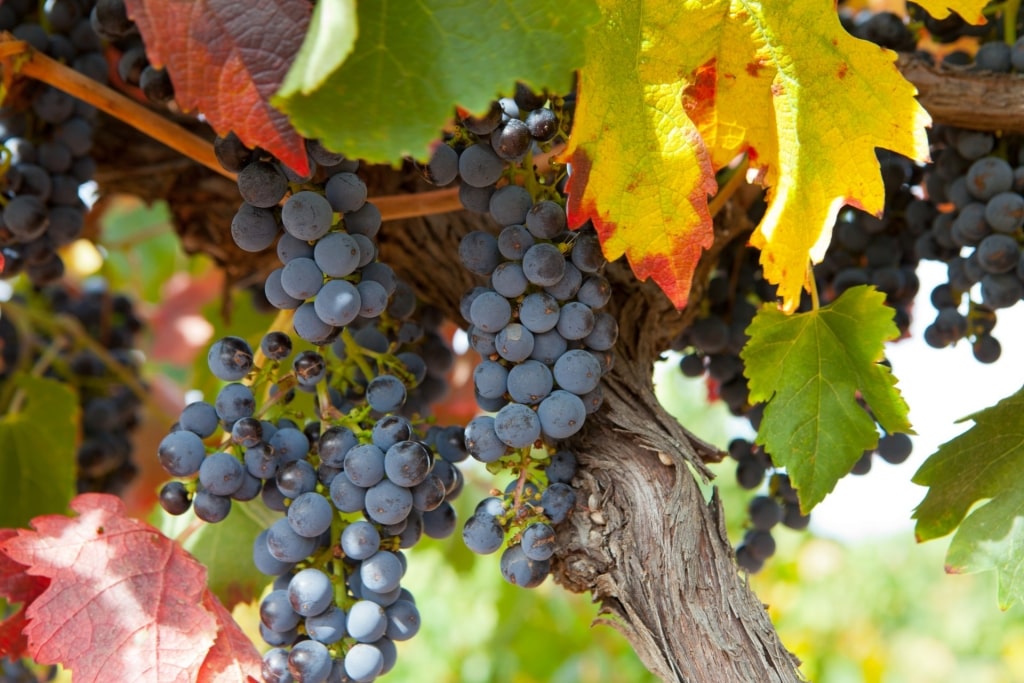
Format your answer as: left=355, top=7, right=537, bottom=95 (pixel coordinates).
left=154, top=500, right=281, bottom=609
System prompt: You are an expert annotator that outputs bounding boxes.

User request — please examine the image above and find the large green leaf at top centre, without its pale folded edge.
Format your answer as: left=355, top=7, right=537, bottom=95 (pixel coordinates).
left=273, top=0, right=598, bottom=163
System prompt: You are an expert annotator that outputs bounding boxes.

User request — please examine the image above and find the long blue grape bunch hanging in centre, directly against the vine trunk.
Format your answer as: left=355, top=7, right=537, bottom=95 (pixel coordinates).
left=415, top=84, right=606, bottom=587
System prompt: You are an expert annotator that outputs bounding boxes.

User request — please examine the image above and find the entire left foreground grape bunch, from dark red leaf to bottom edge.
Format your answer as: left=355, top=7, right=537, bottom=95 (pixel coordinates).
left=158, top=140, right=467, bottom=683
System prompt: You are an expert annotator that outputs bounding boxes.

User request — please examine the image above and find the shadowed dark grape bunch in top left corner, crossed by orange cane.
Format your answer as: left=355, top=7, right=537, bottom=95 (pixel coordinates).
left=0, top=0, right=108, bottom=286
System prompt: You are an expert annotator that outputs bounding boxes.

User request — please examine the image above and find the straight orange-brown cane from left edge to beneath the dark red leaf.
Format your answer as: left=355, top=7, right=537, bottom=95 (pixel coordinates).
left=0, top=32, right=228, bottom=180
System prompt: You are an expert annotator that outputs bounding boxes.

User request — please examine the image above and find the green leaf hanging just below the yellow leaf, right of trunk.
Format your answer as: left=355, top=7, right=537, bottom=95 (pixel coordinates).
left=740, top=286, right=910, bottom=513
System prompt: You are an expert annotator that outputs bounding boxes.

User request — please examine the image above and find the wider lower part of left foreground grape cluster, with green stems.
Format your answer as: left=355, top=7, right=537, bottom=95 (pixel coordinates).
left=158, top=331, right=466, bottom=683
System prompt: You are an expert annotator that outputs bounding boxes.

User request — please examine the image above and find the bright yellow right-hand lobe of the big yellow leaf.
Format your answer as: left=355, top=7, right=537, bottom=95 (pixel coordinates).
left=716, top=0, right=931, bottom=310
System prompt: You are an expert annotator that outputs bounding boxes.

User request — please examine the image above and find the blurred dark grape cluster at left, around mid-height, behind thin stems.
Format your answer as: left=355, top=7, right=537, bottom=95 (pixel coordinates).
left=0, top=281, right=141, bottom=495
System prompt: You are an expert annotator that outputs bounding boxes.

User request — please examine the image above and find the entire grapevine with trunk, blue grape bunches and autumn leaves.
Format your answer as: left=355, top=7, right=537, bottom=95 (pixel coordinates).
left=0, top=0, right=1024, bottom=683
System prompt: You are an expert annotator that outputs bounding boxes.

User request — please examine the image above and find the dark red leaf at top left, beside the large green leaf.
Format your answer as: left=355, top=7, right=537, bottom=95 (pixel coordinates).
left=125, top=0, right=312, bottom=174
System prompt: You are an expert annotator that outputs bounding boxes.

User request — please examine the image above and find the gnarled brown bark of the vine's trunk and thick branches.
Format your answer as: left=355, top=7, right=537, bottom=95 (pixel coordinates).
left=83, top=55, right=1024, bottom=683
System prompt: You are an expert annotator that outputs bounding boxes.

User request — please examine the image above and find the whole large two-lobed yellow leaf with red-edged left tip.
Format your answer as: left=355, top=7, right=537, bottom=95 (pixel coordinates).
left=569, top=0, right=929, bottom=310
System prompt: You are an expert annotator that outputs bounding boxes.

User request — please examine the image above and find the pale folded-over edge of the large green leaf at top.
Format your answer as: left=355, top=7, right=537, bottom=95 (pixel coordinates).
left=281, top=0, right=358, bottom=97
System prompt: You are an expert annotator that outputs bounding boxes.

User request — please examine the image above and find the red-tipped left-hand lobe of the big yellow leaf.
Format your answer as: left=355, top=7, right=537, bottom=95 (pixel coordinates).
left=563, top=0, right=716, bottom=307
